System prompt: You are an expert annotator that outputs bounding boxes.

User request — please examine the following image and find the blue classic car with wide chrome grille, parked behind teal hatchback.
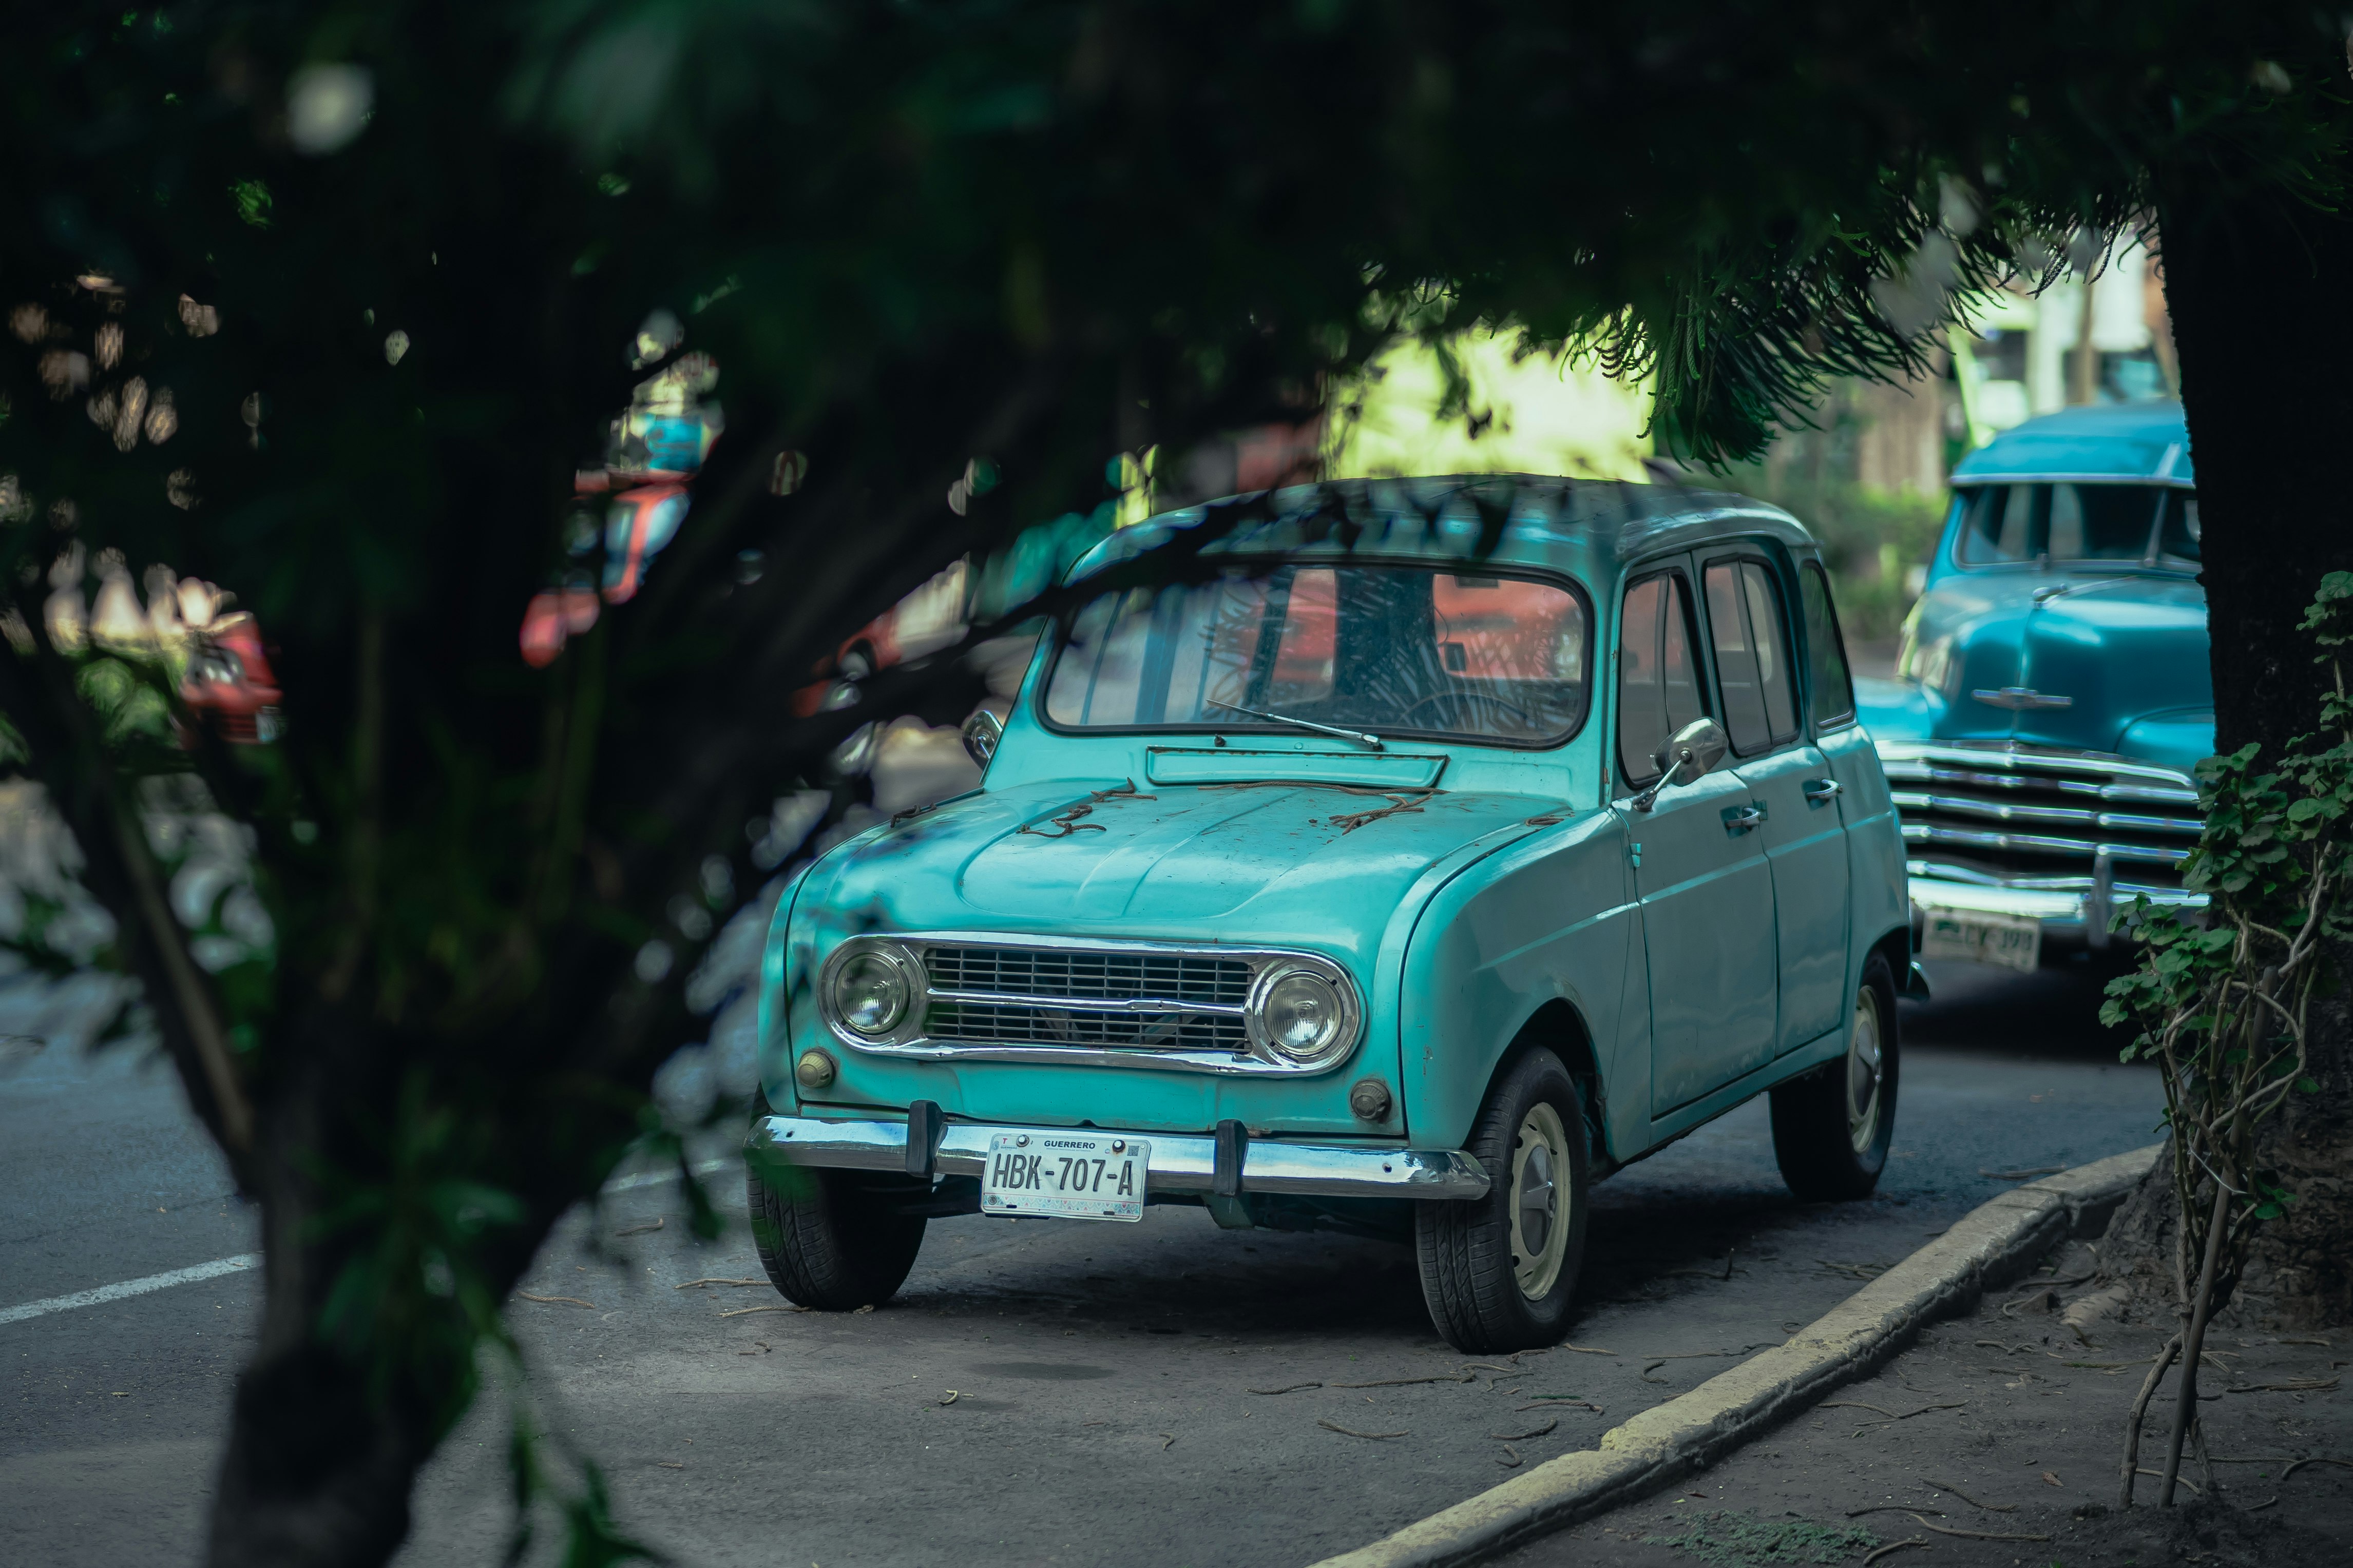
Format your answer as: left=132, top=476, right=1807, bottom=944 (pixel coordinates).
left=1859, top=402, right=2214, bottom=969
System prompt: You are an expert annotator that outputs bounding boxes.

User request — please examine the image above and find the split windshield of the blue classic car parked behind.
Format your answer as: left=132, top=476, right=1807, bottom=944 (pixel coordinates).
left=1953, top=485, right=2198, bottom=567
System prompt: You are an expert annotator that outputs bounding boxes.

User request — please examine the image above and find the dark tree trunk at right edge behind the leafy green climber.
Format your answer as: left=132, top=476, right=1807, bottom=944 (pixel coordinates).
left=2111, top=147, right=2353, bottom=1326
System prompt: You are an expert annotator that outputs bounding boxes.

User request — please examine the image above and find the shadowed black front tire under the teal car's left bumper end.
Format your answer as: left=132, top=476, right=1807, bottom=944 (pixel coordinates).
left=746, top=1168, right=927, bottom=1312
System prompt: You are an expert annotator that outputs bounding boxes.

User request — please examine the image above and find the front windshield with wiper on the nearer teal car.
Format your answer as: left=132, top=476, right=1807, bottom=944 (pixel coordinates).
left=1045, top=564, right=1589, bottom=745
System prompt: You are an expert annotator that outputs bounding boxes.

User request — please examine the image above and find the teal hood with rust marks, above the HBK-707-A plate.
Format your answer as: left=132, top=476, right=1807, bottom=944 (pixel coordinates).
left=798, top=781, right=1562, bottom=955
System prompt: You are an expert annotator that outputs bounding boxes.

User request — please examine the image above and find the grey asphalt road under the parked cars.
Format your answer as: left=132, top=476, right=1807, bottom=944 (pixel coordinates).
left=0, top=969, right=2158, bottom=1568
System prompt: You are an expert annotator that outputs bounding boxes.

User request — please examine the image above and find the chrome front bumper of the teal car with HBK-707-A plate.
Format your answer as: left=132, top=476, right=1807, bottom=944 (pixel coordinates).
left=743, top=1117, right=1487, bottom=1199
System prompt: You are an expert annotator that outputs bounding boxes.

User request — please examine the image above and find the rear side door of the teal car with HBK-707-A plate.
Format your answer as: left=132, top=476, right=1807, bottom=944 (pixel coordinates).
left=1699, top=550, right=1847, bottom=1056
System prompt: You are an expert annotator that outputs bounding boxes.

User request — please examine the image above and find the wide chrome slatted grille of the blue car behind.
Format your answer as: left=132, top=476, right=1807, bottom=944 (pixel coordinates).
left=1880, top=741, right=2205, bottom=898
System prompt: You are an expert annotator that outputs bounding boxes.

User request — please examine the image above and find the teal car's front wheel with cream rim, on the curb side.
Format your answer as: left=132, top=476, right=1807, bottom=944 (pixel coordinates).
left=1414, top=1049, right=1591, bottom=1354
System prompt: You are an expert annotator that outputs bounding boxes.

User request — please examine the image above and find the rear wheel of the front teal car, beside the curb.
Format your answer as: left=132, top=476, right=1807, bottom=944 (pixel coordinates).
left=1772, top=955, right=1904, bottom=1204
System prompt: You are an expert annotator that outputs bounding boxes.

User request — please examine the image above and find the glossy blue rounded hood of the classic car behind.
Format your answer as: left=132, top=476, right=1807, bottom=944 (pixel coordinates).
left=1866, top=571, right=2214, bottom=762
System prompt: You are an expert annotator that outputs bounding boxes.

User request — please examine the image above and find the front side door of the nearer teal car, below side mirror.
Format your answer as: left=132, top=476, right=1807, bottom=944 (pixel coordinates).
left=1612, top=557, right=1776, bottom=1117
